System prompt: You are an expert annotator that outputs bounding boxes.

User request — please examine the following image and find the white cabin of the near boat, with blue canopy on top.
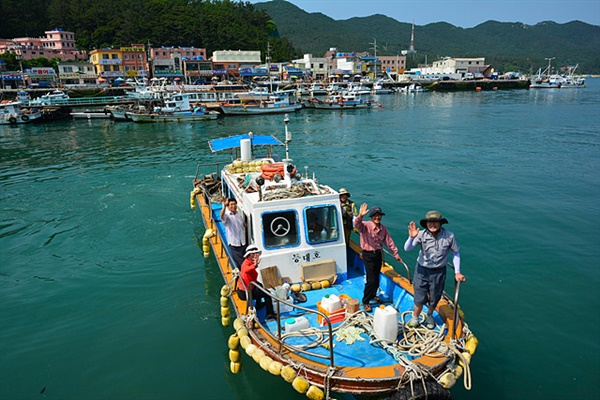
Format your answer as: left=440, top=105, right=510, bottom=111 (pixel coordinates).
left=211, top=133, right=347, bottom=282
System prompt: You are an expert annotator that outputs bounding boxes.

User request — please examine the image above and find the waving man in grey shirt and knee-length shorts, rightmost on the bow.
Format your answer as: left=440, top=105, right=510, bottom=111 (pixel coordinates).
left=404, top=211, right=466, bottom=329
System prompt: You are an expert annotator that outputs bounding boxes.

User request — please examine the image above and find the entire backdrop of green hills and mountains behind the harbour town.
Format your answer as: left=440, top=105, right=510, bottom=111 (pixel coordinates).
left=0, top=0, right=600, bottom=73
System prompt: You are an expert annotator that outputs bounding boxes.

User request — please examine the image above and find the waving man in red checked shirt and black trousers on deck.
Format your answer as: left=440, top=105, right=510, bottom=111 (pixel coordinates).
left=354, top=203, right=402, bottom=312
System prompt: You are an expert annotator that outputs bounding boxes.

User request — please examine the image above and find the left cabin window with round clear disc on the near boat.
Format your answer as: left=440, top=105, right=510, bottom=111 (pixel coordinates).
left=262, top=210, right=299, bottom=249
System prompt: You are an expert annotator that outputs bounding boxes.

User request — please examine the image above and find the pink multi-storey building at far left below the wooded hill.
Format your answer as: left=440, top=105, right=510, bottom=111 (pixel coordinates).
left=0, top=28, right=88, bottom=61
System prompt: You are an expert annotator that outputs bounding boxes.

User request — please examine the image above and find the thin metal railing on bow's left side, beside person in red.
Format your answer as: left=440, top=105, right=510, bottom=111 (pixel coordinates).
left=245, top=280, right=335, bottom=368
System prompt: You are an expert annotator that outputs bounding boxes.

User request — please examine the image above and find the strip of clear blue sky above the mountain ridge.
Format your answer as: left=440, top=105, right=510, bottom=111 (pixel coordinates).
left=250, top=0, right=600, bottom=28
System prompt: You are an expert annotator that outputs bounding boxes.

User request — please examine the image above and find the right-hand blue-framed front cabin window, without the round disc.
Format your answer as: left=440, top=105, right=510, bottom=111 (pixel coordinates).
left=304, top=205, right=340, bottom=244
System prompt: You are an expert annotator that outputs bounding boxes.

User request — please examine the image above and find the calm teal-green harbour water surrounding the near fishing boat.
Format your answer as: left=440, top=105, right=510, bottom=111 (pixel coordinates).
left=0, top=79, right=600, bottom=400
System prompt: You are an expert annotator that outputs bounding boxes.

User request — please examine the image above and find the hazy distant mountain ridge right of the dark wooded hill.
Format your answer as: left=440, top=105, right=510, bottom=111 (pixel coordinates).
left=255, top=0, right=600, bottom=73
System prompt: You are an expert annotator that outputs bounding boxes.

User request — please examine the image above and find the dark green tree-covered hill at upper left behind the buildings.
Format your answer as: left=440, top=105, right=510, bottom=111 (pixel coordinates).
left=0, top=0, right=297, bottom=60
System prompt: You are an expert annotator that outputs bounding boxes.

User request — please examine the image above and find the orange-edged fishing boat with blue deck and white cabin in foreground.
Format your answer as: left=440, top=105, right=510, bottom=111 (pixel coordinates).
left=190, top=116, right=477, bottom=400
